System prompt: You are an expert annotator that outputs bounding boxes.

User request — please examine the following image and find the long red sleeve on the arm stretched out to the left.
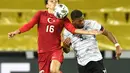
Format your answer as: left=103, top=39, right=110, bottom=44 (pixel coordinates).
left=19, top=11, right=41, bottom=33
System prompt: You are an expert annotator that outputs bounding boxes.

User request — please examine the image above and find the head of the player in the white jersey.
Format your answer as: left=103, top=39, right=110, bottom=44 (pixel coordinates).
left=71, top=10, right=84, bottom=28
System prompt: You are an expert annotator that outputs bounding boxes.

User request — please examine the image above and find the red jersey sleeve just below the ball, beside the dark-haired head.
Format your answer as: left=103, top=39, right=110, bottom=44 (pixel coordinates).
left=64, top=18, right=75, bottom=34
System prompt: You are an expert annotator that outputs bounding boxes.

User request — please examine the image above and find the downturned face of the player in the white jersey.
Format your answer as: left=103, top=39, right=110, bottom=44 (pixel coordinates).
left=72, top=18, right=84, bottom=29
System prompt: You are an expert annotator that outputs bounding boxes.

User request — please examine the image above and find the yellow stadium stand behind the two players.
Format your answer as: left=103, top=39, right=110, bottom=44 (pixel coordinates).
left=0, top=0, right=130, bottom=51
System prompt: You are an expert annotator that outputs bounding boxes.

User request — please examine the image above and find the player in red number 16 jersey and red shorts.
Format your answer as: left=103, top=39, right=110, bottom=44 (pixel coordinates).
left=8, top=0, right=100, bottom=73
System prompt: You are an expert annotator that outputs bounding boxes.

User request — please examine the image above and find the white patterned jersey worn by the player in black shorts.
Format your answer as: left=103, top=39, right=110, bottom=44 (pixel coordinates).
left=63, top=20, right=102, bottom=66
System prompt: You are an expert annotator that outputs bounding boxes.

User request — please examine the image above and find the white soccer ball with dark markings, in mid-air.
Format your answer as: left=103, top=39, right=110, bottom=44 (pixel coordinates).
left=54, top=4, right=69, bottom=19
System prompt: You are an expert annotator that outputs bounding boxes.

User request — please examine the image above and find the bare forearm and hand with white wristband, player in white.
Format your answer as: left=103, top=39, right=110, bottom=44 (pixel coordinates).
left=102, top=27, right=122, bottom=59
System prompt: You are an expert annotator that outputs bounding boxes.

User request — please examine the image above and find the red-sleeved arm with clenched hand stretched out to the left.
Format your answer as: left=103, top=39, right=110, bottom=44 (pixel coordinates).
left=8, top=11, right=41, bottom=38
